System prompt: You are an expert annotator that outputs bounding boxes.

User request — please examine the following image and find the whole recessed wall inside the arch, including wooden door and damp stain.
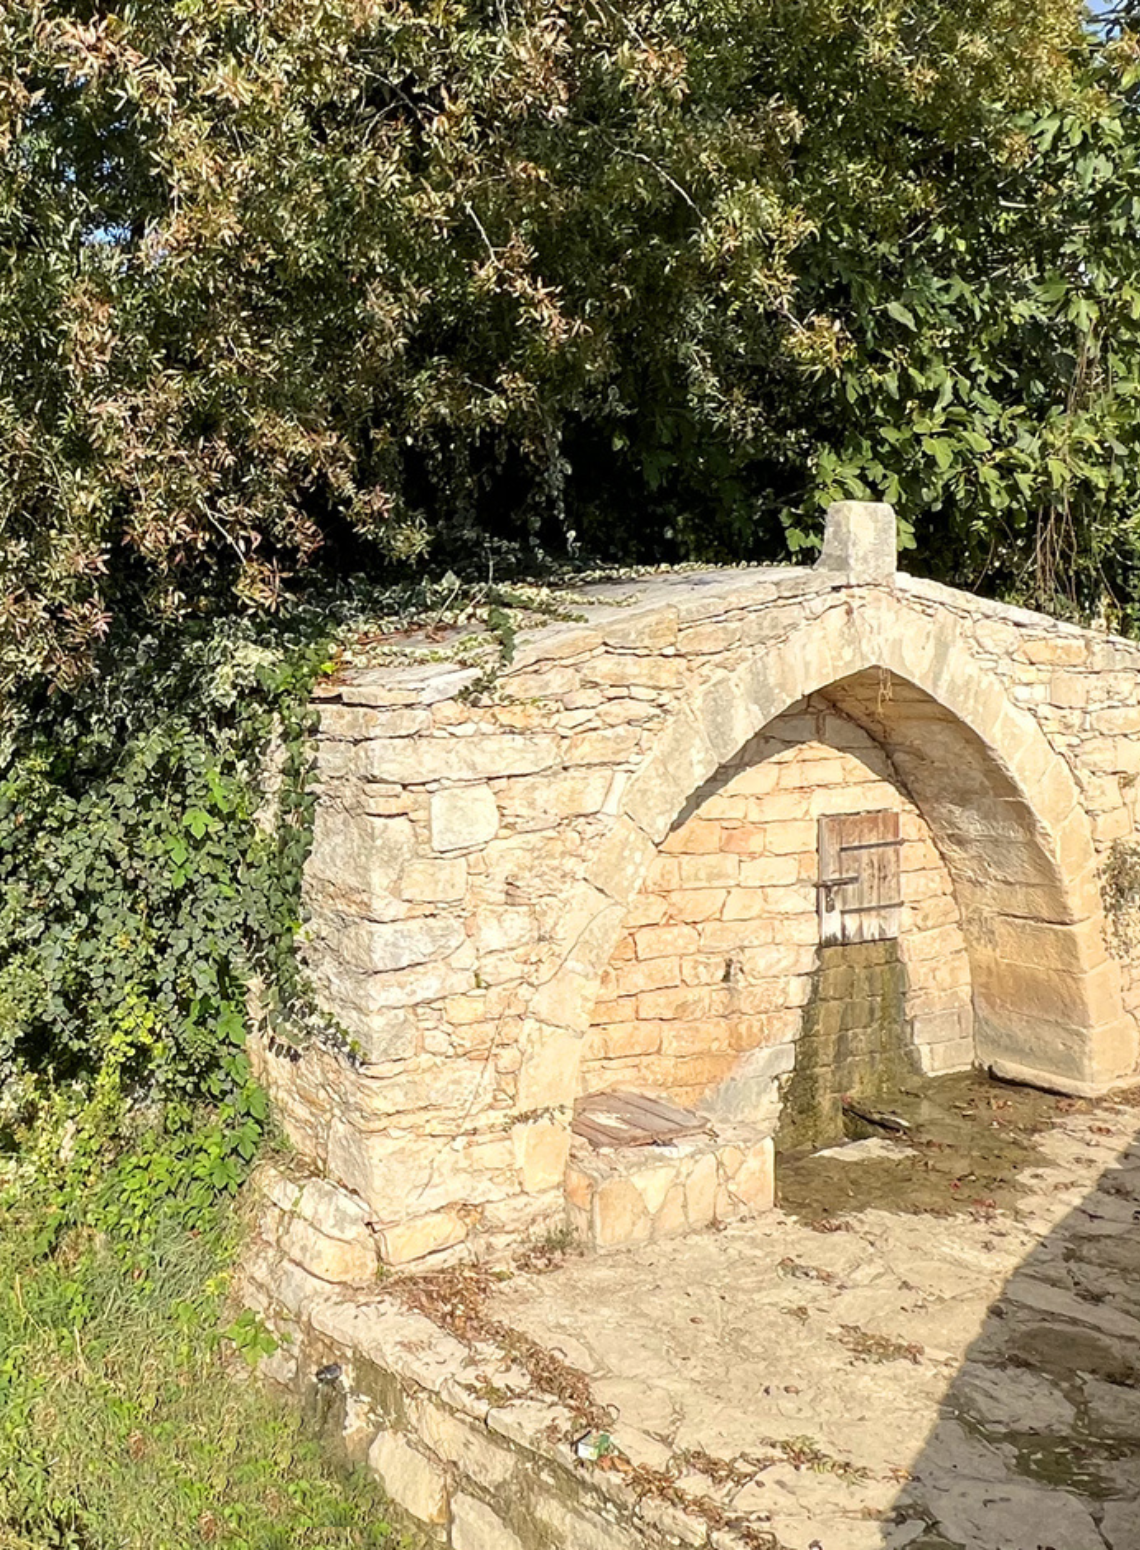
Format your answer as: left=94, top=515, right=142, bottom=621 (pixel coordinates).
left=580, top=690, right=974, bottom=1144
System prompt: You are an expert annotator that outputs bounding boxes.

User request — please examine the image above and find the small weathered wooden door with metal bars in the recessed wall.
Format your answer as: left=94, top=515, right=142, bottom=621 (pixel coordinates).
left=819, top=811, right=903, bottom=947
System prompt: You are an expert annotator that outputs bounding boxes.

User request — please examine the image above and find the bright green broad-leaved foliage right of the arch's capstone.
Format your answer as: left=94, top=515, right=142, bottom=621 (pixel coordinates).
left=813, top=37, right=1140, bottom=629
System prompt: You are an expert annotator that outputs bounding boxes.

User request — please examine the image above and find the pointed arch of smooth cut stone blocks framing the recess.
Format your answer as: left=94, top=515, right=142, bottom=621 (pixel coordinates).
left=520, top=594, right=1135, bottom=1107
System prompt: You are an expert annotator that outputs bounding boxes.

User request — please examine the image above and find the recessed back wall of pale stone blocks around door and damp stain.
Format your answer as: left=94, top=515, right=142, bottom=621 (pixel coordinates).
left=580, top=694, right=974, bottom=1119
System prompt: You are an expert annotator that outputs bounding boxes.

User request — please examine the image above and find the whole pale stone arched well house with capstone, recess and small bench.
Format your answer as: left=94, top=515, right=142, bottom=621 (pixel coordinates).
left=249, top=502, right=1140, bottom=1280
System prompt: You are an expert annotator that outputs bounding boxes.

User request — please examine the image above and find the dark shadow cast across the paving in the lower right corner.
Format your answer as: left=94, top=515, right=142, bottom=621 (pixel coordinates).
left=883, top=1124, right=1140, bottom=1550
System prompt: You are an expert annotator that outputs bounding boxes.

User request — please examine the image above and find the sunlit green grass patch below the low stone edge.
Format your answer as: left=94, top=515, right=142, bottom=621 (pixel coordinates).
left=0, top=1184, right=397, bottom=1550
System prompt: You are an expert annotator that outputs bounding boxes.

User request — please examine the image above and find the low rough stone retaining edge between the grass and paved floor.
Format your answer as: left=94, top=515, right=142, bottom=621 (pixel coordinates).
left=240, top=1242, right=766, bottom=1550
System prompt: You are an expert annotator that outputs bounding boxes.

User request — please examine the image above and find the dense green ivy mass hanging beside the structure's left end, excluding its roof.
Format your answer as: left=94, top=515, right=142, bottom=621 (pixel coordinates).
left=0, top=604, right=335, bottom=1226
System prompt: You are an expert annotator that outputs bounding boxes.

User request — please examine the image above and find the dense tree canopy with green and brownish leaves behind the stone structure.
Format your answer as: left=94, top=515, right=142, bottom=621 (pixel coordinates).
left=0, top=0, right=1140, bottom=687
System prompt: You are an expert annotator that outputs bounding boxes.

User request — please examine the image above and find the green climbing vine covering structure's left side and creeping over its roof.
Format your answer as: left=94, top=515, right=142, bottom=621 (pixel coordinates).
left=0, top=577, right=580, bottom=1242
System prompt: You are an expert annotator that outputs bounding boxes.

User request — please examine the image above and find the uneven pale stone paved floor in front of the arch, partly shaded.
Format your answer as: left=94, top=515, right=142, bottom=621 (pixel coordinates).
left=489, top=1102, right=1140, bottom=1550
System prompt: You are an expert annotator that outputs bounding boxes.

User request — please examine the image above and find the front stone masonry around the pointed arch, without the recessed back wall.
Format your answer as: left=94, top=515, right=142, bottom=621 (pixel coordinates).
left=248, top=508, right=1140, bottom=1265
